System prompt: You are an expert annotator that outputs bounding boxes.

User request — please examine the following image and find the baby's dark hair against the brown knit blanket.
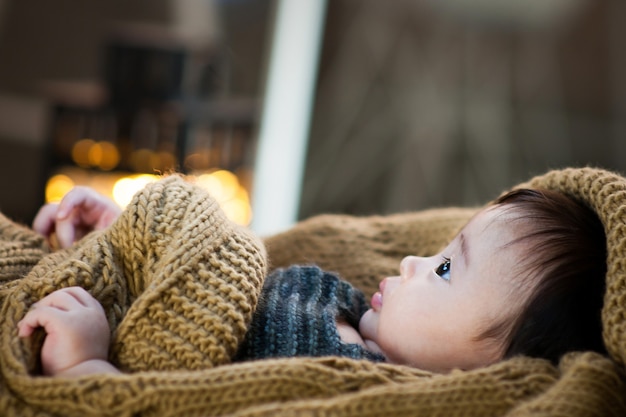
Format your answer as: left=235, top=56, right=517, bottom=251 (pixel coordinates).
left=483, top=189, right=607, bottom=363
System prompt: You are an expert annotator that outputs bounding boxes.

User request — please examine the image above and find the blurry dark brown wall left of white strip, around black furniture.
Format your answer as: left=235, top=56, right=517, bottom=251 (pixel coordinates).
left=0, top=0, right=270, bottom=223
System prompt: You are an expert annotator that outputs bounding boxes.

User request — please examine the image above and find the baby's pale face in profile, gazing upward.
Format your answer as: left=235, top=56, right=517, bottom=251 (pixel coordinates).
left=360, top=206, right=531, bottom=372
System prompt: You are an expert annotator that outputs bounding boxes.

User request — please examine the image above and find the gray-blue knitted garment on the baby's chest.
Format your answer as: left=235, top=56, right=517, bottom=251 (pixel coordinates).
left=234, top=266, right=384, bottom=362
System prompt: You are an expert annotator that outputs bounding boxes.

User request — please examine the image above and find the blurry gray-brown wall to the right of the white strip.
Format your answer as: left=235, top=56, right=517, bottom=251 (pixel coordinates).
left=301, top=0, right=626, bottom=217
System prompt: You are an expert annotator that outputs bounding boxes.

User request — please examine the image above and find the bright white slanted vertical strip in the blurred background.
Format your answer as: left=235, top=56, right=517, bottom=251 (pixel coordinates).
left=251, top=0, right=326, bottom=236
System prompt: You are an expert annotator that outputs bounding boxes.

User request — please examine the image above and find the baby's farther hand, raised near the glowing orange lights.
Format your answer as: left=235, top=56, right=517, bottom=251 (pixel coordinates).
left=33, top=186, right=122, bottom=248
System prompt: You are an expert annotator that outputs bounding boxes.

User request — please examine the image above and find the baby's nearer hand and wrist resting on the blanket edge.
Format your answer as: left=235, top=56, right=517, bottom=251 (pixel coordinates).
left=18, top=287, right=119, bottom=376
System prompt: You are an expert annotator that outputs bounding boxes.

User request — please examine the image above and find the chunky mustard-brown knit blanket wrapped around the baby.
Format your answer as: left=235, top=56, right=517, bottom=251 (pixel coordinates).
left=0, top=168, right=626, bottom=416
